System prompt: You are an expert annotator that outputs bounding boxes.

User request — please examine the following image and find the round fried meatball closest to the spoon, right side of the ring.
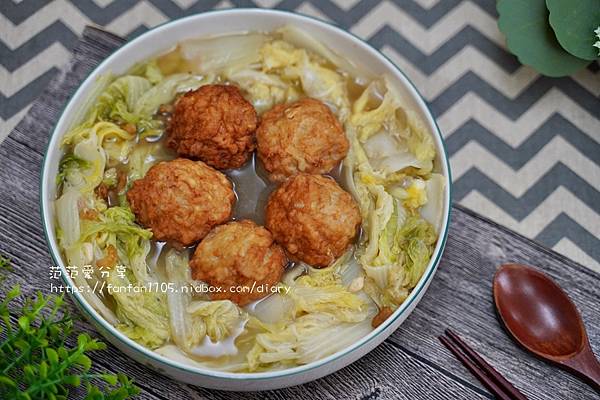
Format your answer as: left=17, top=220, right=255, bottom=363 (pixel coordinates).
left=265, top=174, right=360, bottom=267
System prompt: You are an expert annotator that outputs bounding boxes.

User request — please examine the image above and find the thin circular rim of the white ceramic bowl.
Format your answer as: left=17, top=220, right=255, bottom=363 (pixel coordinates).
left=39, top=8, right=452, bottom=381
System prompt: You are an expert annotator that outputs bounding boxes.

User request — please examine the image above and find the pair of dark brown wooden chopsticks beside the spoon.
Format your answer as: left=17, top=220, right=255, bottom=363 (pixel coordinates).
left=439, top=329, right=527, bottom=400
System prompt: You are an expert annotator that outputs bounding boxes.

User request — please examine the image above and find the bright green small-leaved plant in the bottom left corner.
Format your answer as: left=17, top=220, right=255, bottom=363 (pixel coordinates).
left=0, top=257, right=139, bottom=400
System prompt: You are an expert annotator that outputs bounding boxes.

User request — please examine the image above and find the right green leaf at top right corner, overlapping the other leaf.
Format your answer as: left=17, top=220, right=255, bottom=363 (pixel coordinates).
left=546, top=0, right=600, bottom=61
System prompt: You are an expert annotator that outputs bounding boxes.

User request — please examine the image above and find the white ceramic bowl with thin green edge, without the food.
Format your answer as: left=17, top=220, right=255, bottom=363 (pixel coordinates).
left=41, top=9, right=451, bottom=391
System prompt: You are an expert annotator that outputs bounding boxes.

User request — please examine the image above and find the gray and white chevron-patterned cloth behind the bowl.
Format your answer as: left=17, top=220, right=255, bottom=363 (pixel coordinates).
left=0, top=0, right=600, bottom=272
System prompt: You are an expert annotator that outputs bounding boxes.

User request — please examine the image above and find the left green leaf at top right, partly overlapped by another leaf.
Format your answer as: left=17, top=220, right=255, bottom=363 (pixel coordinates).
left=497, top=0, right=591, bottom=77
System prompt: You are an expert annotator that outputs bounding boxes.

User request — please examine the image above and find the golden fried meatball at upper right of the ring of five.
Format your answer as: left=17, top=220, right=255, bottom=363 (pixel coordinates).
left=256, top=98, right=349, bottom=182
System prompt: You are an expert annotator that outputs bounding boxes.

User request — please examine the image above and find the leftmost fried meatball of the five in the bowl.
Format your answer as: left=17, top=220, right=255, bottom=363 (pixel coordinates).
left=127, top=158, right=235, bottom=246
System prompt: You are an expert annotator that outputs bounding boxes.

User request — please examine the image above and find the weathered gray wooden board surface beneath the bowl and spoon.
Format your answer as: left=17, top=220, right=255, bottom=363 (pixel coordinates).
left=0, top=29, right=600, bottom=400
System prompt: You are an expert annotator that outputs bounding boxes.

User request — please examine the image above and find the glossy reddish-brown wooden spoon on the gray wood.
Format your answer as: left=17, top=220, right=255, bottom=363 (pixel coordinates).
left=493, top=264, right=600, bottom=391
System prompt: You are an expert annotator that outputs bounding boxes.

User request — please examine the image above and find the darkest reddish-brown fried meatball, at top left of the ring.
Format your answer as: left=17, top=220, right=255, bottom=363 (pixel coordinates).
left=167, top=85, right=258, bottom=169
